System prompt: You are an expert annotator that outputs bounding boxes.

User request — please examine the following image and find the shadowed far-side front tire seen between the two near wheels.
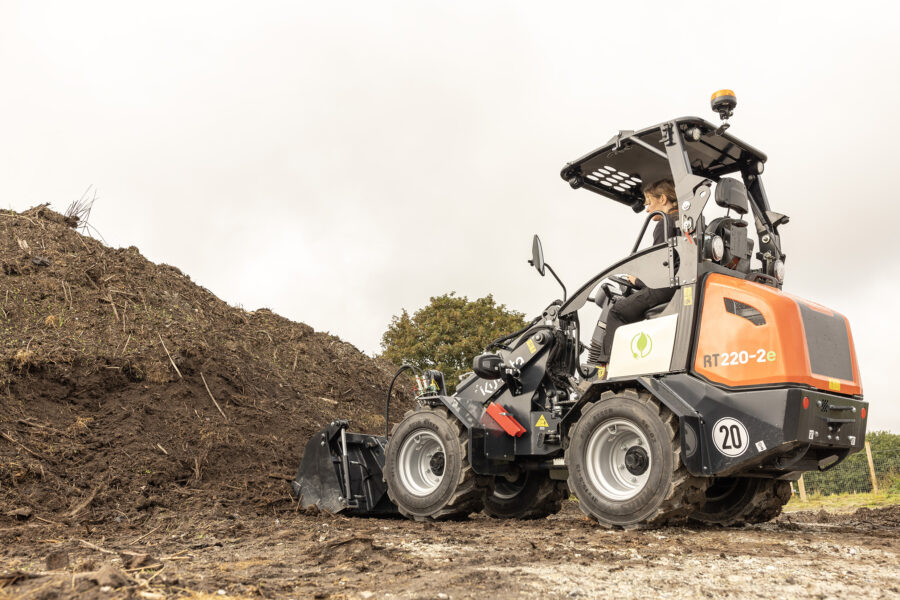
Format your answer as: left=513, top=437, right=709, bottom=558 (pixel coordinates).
left=484, top=471, right=568, bottom=519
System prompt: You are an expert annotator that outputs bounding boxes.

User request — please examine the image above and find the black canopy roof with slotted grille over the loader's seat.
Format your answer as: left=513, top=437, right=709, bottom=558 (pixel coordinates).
left=560, top=117, right=768, bottom=212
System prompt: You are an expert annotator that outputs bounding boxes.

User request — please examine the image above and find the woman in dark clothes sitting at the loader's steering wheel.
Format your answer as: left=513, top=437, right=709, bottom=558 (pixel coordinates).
left=597, top=179, right=681, bottom=379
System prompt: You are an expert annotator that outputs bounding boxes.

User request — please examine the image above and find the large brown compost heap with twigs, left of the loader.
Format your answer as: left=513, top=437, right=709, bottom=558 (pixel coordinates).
left=0, top=206, right=412, bottom=523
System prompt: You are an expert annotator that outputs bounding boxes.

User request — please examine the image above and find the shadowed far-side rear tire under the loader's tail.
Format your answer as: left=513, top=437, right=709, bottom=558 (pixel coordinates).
left=690, top=477, right=791, bottom=527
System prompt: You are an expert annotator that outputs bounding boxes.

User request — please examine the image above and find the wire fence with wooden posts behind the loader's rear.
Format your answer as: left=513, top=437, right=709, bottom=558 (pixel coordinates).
left=793, top=448, right=900, bottom=496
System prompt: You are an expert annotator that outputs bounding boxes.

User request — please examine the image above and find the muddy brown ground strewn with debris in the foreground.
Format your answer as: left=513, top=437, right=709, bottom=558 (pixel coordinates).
left=0, top=502, right=900, bottom=599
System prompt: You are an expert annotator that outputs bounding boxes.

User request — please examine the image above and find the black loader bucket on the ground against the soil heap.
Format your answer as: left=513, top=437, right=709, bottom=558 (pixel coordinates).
left=291, top=420, right=399, bottom=516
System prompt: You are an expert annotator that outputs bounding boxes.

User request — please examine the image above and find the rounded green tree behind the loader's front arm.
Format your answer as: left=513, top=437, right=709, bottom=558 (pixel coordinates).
left=381, top=292, right=526, bottom=393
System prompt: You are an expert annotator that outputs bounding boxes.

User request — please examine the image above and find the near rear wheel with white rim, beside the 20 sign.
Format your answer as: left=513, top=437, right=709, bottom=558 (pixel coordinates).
left=566, top=389, right=707, bottom=528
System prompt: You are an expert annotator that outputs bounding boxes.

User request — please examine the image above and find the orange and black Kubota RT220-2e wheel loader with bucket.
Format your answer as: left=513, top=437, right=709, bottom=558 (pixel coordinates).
left=293, top=90, right=868, bottom=527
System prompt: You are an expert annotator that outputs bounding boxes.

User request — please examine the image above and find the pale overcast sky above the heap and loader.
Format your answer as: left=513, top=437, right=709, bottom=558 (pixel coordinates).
left=0, top=0, right=900, bottom=432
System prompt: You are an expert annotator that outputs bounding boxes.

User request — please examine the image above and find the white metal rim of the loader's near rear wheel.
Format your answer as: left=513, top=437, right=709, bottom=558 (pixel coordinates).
left=585, top=419, right=653, bottom=501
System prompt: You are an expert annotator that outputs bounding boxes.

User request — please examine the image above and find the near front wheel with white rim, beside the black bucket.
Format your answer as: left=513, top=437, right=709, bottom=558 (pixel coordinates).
left=384, top=406, right=488, bottom=521
